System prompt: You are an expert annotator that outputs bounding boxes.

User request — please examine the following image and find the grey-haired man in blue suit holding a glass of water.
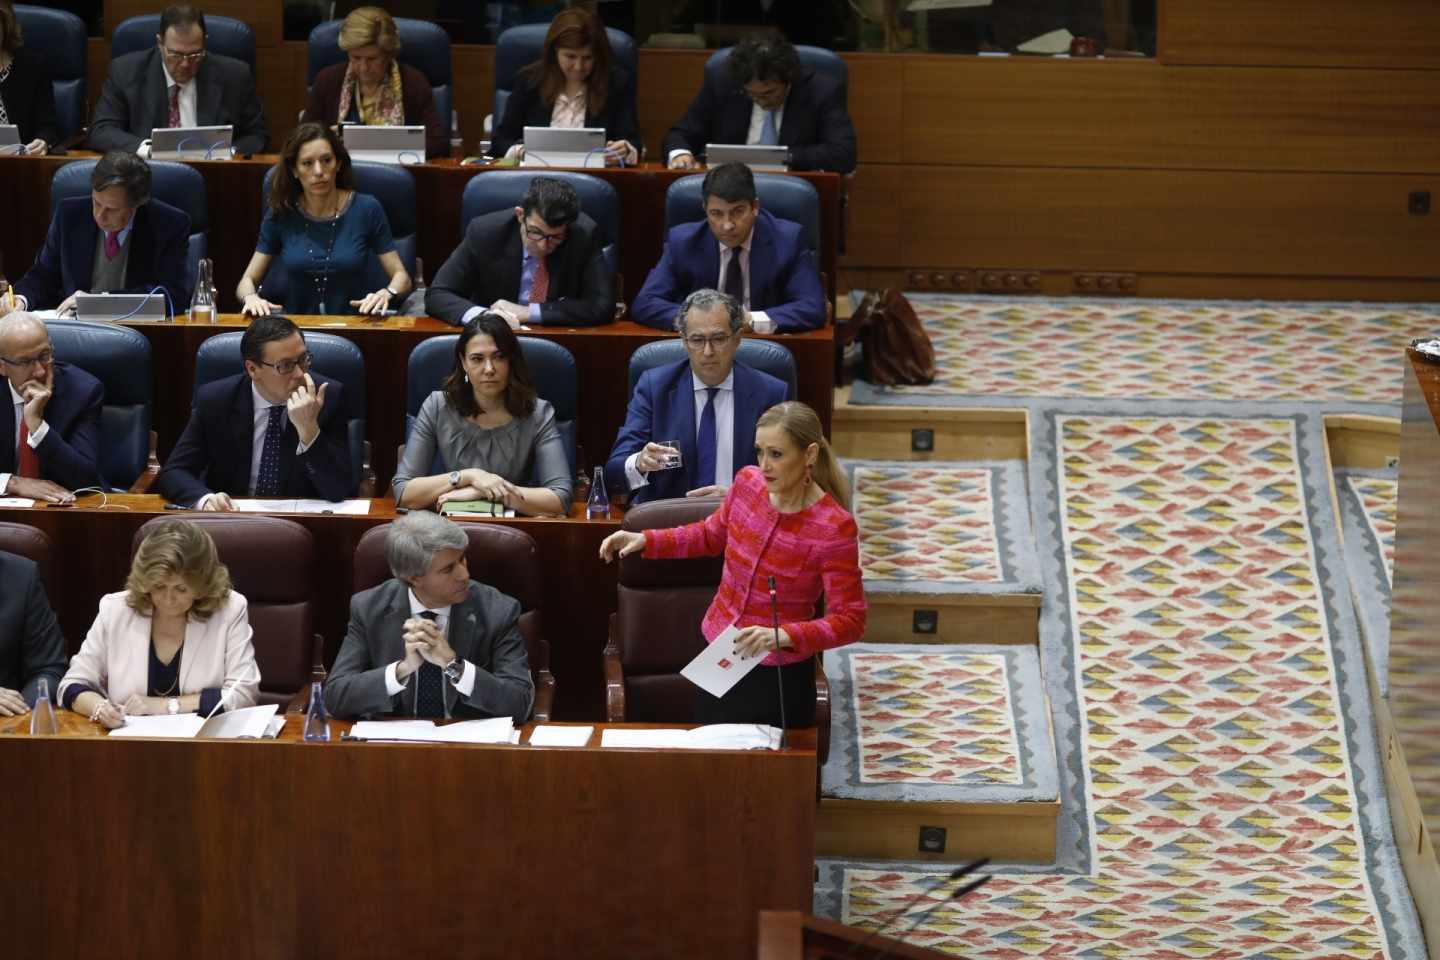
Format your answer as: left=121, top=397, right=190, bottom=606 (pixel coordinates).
left=605, top=289, right=786, bottom=502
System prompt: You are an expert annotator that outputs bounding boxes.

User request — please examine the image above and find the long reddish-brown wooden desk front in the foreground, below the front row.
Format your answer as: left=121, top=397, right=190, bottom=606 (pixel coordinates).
left=0, top=714, right=815, bottom=960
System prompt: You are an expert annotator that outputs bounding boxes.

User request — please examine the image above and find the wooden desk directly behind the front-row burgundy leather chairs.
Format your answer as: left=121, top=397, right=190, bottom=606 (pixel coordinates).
left=0, top=494, right=624, bottom=720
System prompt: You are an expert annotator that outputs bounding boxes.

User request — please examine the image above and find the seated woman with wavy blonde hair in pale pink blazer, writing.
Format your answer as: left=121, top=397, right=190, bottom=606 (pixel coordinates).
left=58, top=520, right=261, bottom=728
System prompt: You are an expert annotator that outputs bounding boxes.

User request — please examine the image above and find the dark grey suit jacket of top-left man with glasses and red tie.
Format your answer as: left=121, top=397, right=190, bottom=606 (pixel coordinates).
left=89, top=46, right=269, bottom=154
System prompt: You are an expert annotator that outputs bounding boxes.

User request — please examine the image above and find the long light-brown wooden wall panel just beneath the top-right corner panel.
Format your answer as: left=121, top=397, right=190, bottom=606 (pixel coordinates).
left=903, top=56, right=1440, bottom=173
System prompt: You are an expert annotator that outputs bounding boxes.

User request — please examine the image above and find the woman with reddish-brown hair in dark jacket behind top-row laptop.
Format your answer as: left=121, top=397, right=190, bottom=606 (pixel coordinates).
left=491, top=7, right=641, bottom=166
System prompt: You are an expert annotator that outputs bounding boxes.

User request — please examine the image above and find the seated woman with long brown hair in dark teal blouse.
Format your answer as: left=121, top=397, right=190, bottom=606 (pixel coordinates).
left=235, top=124, right=410, bottom=317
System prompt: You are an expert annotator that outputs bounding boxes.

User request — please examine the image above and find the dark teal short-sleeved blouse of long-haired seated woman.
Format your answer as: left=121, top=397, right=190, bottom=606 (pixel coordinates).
left=255, top=193, right=395, bottom=315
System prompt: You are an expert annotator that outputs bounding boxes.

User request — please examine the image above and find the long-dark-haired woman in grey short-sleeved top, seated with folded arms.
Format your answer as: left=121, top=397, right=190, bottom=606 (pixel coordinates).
left=395, top=312, right=573, bottom=514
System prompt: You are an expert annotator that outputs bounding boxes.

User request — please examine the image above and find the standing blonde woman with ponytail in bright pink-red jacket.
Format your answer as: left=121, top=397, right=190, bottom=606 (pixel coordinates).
left=600, top=402, right=865, bottom=727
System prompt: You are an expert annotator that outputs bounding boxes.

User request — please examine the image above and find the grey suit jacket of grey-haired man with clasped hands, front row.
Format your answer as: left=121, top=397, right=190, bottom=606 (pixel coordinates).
left=325, top=580, right=536, bottom=724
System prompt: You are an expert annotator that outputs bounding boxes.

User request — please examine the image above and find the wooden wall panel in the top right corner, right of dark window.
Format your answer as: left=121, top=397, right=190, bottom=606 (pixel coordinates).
left=1159, top=0, right=1440, bottom=69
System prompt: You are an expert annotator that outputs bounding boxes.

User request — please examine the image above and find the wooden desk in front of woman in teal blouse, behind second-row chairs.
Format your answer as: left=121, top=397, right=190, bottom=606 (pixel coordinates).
left=130, top=314, right=835, bottom=492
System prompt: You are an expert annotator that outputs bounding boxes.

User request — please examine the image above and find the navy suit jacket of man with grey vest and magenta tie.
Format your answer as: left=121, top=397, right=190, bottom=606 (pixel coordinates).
left=14, top=197, right=190, bottom=314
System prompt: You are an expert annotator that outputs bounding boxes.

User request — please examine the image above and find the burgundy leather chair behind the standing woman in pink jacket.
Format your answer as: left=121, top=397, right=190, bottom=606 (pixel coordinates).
left=611, top=498, right=724, bottom=723
